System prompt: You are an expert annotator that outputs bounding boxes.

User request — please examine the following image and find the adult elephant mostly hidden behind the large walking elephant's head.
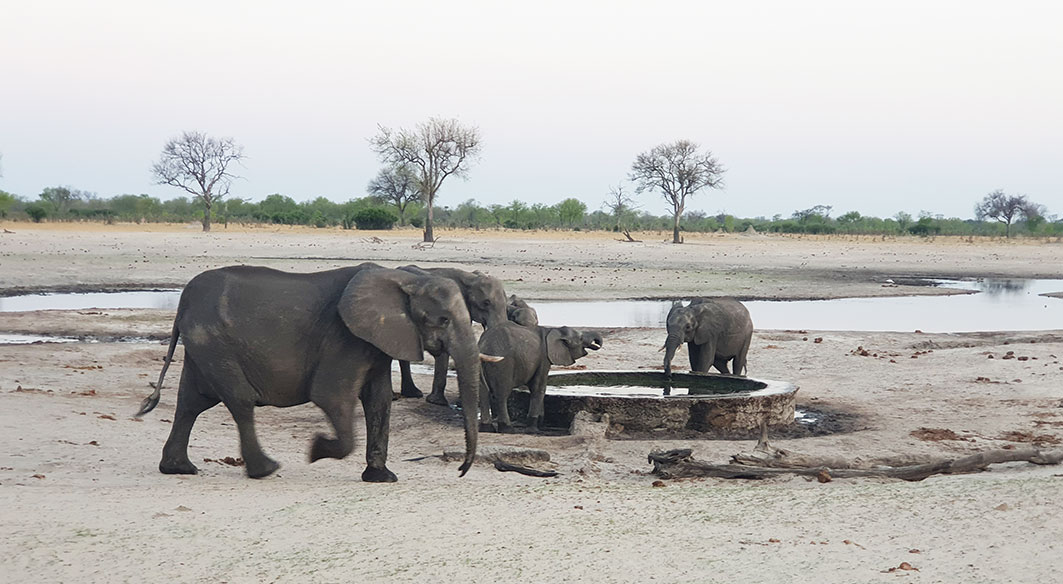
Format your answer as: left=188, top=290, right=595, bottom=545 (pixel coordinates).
left=399, top=266, right=506, bottom=405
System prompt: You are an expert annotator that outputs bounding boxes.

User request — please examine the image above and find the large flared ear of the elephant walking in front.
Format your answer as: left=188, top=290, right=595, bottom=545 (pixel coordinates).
left=337, top=268, right=424, bottom=361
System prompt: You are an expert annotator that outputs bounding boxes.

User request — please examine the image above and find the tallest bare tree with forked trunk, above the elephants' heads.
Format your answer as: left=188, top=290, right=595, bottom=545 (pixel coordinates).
left=370, top=118, right=482, bottom=243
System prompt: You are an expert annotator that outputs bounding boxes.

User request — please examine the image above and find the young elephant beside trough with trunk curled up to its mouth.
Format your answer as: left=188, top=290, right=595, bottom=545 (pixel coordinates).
left=479, top=322, right=602, bottom=432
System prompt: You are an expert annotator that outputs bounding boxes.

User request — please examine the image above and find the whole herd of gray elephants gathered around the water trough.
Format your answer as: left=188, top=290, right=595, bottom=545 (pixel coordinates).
left=136, top=262, right=753, bottom=482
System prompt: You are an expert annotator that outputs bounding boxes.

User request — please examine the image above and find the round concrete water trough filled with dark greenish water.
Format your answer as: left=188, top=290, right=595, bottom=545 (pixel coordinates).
left=510, top=370, right=797, bottom=437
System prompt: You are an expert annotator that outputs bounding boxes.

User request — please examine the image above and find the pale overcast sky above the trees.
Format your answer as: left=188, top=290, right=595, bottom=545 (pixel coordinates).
left=0, top=0, right=1063, bottom=218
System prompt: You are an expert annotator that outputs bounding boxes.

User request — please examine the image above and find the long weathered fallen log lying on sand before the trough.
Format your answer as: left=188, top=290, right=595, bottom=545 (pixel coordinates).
left=649, top=447, right=1063, bottom=482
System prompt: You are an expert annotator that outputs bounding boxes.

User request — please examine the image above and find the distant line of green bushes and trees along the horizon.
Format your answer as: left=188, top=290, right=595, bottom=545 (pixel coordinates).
left=0, top=187, right=1063, bottom=237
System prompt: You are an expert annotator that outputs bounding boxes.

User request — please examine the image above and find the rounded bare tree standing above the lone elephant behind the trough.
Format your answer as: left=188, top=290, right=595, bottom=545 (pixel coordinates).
left=628, top=139, right=725, bottom=244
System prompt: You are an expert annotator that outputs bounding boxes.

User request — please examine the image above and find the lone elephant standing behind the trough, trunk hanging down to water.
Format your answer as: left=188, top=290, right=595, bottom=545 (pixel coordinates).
left=663, top=298, right=753, bottom=376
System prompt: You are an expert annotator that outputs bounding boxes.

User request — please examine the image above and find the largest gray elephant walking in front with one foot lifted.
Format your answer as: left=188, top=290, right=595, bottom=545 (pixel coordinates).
left=137, top=263, right=479, bottom=482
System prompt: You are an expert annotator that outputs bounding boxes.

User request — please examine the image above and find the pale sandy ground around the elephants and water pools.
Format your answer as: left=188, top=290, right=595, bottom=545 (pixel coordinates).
left=0, top=223, right=1063, bottom=582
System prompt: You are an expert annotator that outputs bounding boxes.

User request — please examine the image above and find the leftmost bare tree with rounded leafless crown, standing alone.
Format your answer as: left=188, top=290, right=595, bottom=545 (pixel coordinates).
left=151, top=132, right=243, bottom=231
